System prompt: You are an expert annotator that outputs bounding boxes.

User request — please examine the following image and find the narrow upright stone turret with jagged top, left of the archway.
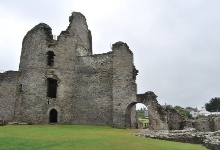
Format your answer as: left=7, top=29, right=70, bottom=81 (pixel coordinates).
left=112, top=42, right=137, bottom=128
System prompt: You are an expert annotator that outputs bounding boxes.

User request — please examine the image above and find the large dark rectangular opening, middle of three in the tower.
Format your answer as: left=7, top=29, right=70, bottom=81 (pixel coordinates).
left=47, top=78, right=57, bottom=98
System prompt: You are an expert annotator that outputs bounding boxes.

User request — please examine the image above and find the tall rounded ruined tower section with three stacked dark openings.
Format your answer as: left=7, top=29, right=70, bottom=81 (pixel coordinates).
left=16, top=12, right=92, bottom=124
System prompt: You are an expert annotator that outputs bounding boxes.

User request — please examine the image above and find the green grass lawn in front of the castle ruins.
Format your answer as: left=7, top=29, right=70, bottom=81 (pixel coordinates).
left=0, top=125, right=205, bottom=150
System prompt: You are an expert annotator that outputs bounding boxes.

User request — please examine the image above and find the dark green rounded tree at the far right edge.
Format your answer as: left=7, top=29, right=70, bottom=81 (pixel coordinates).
left=205, top=97, right=220, bottom=112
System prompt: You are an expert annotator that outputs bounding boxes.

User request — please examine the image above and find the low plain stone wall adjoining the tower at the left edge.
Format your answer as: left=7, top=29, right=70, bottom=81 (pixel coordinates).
left=0, top=71, right=19, bottom=121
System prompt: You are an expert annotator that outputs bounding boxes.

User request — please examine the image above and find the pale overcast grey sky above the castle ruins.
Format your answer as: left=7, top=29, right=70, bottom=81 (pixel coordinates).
left=0, top=0, right=220, bottom=108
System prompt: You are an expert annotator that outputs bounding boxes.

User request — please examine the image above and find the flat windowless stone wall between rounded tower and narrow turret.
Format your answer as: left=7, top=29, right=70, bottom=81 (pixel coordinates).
left=72, top=53, right=113, bottom=126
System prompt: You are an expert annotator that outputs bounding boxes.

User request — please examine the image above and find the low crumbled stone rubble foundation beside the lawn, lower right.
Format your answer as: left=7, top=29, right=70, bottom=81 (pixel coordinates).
left=133, top=128, right=220, bottom=150
